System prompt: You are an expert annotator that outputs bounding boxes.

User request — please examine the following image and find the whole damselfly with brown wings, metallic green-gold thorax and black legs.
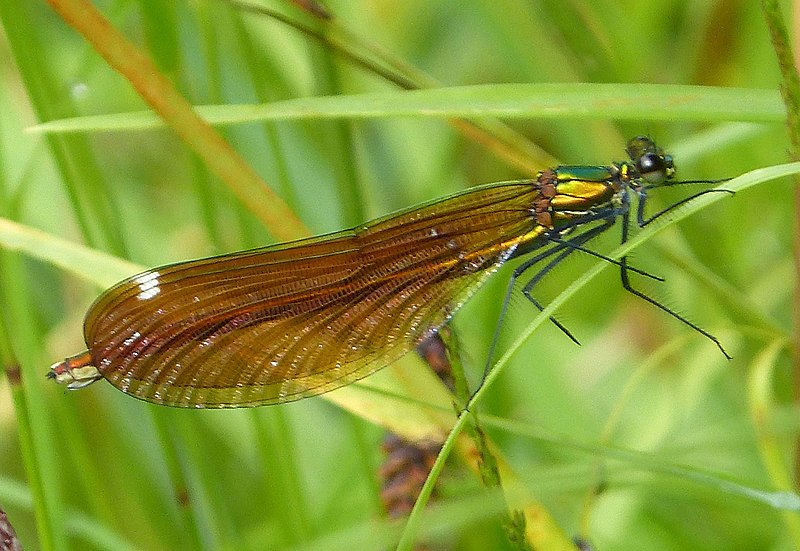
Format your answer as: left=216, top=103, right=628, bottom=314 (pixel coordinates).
left=48, top=137, right=727, bottom=408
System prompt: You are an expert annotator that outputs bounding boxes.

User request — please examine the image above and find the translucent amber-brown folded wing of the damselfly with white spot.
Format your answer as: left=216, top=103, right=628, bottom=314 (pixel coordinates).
left=84, top=182, right=540, bottom=407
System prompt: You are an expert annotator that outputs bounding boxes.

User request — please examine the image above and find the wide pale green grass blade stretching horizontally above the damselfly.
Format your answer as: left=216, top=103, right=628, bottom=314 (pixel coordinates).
left=30, top=83, right=785, bottom=133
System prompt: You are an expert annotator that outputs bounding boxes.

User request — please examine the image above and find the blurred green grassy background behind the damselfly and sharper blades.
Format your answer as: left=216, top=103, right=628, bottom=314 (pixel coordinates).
left=0, top=0, right=800, bottom=551
